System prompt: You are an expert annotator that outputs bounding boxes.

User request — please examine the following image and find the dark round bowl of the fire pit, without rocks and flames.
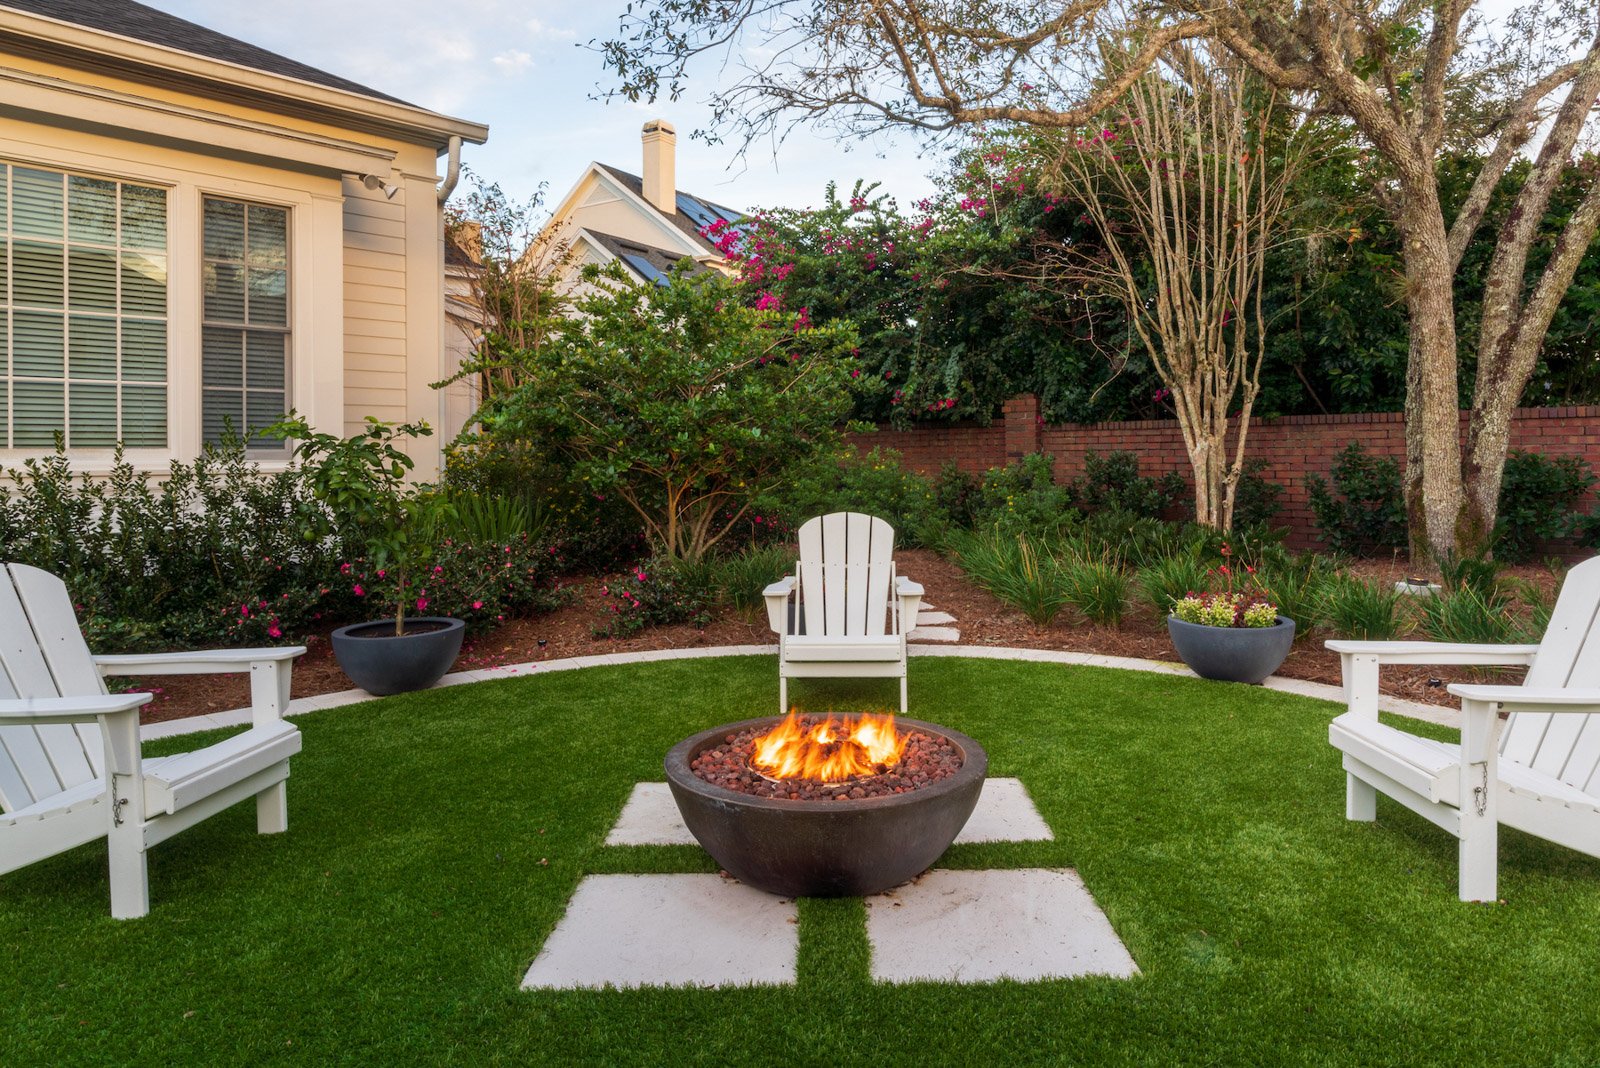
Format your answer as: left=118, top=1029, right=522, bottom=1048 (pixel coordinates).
left=666, top=716, right=989, bottom=897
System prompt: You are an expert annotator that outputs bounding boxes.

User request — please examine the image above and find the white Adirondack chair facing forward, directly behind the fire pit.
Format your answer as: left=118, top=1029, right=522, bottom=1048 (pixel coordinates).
left=765, top=512, right=922, bottom=713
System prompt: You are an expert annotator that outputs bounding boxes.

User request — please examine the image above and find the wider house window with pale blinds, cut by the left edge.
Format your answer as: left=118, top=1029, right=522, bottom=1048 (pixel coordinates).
left=0, top=163, right=166, bottom=449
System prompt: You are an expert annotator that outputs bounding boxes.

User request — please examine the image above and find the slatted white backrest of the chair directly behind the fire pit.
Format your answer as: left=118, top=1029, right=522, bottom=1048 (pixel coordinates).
left=797, top=512, right=894, bottom=638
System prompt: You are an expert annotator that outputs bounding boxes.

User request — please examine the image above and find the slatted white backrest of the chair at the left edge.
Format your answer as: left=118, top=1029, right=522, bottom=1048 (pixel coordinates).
left=0, top=564, right=106, bottom=812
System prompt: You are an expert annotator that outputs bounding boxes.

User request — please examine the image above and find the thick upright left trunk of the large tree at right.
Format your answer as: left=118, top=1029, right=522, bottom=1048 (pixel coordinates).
left=1402, top=191, right=1462, bottom=563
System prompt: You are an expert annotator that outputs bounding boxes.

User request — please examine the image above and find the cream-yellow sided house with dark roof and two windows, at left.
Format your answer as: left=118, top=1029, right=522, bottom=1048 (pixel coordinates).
left=0, top=0, right=488, bottom=478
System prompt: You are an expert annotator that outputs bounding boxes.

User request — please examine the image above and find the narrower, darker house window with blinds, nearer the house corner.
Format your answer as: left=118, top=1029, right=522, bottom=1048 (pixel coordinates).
left=200, top=197, right=290, bottom=441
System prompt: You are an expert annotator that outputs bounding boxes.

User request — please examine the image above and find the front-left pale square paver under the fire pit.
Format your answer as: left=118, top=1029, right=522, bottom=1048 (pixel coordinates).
left=522, top=875, right=800, bottom=990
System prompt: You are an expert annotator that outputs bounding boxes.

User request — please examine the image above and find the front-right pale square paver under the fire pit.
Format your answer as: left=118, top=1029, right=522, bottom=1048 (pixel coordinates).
left=866, top=868, right=1139, bottom=983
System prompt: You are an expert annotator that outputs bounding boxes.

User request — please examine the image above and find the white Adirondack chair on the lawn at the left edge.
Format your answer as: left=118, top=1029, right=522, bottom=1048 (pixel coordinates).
left=0, top=564, right=306, bottom=919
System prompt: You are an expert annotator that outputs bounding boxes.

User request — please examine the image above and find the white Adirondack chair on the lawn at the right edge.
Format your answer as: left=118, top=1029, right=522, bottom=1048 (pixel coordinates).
left=1328, top=558, right=1600, bottom=902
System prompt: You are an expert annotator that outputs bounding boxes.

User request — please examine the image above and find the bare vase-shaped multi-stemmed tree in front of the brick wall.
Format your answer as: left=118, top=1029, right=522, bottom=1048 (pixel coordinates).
left=1043, top=43, right=1315, bottom=531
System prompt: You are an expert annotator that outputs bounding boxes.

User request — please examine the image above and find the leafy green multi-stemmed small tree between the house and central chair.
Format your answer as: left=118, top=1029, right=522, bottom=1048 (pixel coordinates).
left=480, top=267, right=862, bottom=561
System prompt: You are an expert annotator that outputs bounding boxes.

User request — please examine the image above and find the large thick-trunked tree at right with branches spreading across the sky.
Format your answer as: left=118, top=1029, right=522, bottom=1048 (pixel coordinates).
left=602, top=0, right=1600, bottom=553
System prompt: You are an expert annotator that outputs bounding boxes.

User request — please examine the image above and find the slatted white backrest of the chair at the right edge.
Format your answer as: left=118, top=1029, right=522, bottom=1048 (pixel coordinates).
left=1501, top=556, right=1600, bottom=793
